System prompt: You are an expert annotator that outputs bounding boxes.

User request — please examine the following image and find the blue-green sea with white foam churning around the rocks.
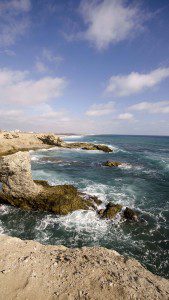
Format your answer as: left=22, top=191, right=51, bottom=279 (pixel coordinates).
left=0, top=135, right=169, bottom=278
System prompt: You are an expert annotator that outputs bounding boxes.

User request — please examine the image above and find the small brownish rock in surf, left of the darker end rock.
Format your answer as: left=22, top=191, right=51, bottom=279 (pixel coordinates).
left=98, top=202, right=122, bottom=220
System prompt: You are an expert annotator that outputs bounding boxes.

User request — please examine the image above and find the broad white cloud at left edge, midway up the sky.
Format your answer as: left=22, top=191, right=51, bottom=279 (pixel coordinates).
left=0, top=69, right=66, bottom=105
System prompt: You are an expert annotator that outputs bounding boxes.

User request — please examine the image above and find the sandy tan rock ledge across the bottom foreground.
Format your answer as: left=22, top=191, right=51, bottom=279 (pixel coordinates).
left=0, top=236, right=169, bottom=300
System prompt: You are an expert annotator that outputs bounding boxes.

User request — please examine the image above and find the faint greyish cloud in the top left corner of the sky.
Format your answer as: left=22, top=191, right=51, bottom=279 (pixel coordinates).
left=0, top=0, right=31, bottom=47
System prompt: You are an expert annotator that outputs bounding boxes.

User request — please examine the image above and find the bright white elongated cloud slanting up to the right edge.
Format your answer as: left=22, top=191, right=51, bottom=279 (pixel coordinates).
left=105, top=68, right=169, bottom=97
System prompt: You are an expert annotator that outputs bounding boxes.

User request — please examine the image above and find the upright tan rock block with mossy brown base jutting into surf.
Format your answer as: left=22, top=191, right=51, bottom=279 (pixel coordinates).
left=0, top=152, right=95, bottom=215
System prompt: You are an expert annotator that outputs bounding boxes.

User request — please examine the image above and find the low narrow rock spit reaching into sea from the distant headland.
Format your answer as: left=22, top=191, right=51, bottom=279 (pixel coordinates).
left=61, top=142, right=113, bottom=153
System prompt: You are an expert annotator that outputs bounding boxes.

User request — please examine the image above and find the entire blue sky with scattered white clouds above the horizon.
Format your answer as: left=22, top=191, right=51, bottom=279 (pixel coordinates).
left=0, top=0, right=169, bottom=135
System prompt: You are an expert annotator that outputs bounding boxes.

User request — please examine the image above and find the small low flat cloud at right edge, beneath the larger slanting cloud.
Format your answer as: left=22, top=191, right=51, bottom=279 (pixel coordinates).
left=128, top=101, right=169, bottom=114
